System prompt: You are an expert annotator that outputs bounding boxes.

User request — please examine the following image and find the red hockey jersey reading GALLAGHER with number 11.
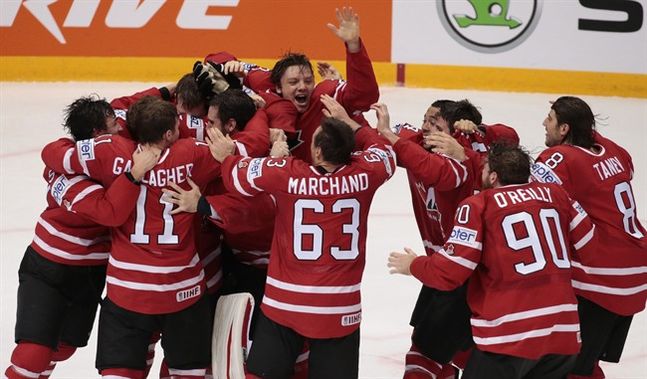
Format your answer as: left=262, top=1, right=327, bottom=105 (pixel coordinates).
left=43, top=136, right=220, bottom=314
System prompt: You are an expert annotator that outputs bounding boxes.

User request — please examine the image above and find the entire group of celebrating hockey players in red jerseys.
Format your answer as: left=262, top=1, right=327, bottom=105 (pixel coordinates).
left=5, top=8, right=647, bottom=379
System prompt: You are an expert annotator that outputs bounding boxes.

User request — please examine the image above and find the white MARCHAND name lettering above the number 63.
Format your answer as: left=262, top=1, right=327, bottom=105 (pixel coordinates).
left=288, top=173, right=368, bottom=196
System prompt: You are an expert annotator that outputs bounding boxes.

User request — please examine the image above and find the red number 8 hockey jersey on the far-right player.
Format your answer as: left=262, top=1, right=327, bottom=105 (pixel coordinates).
left=532, top=134, right=647, bottom=315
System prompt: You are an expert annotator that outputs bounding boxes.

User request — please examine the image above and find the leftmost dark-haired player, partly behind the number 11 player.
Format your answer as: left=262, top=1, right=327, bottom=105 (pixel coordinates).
left=5, top=97, right=158, bottom=379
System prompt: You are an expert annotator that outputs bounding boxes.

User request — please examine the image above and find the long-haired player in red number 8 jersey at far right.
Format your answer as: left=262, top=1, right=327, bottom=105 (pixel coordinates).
left=532, top=96, right=647, bottom=378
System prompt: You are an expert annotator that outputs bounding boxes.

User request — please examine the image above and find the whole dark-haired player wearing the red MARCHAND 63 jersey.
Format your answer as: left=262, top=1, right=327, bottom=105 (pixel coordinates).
left=205, top=97, right=395, bottom=378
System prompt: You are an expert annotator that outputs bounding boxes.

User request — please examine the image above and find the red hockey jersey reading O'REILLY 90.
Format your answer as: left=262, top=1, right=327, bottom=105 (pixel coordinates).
left=411, top=182, right=595, bottom=359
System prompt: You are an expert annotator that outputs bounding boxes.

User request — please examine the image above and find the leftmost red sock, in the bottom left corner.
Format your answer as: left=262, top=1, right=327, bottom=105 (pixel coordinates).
left=5, top=342, right=54, bottom=379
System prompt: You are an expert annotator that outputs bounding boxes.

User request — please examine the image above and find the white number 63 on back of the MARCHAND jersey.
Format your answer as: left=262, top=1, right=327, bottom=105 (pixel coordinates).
left=293, top=199, right=360, bottom=261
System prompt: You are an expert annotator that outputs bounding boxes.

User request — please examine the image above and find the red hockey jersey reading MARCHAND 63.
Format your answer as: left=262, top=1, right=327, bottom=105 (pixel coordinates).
left=223, top=127, right=395, bottom=338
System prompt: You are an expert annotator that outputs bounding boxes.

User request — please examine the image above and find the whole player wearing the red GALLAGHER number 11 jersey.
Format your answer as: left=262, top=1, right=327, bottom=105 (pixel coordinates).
left=44, top=97, right=220, bottom=378
